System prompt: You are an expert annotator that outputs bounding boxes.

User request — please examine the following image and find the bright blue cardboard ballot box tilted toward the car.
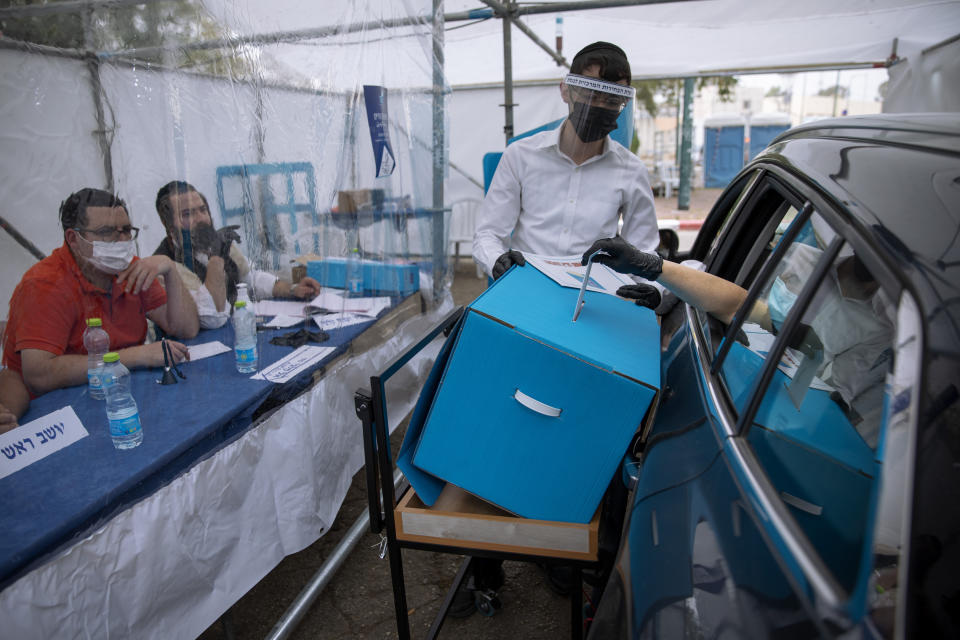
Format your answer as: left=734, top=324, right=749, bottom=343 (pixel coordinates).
left=401, top=266, right=660, bottom=523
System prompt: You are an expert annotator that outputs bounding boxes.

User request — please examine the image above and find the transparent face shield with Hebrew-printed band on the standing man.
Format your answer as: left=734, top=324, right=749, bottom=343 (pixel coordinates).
left=563, top=73, right=637, bottom=143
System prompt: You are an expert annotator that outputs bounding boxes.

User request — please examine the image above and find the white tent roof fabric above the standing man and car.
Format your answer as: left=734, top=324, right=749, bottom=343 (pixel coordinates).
left=444, top=0, right=960, bottom=87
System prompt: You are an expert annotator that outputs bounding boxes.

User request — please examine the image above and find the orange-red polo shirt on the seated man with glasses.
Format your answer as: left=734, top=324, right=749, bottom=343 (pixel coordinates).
left=3, top=244, right=167, bottom=373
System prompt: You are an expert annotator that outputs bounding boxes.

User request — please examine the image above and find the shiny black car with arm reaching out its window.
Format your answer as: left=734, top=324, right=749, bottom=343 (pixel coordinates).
left=590, top=114, right=960, bottom=639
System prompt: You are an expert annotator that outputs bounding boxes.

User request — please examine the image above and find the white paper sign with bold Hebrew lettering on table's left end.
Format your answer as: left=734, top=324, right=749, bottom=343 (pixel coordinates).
left=0, top=407, right=89, bottom=478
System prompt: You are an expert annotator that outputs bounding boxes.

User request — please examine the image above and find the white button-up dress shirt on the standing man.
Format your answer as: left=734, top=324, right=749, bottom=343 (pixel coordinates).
left=473, top=125, right=660, bottom=274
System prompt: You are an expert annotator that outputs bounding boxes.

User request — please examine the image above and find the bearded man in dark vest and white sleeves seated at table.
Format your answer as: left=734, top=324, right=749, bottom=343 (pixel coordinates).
left=154, top=180, right=320, bottom=329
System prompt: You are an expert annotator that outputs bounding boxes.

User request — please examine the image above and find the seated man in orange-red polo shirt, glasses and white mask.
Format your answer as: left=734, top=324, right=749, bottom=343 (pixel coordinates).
left=3, top=189, right=199, bottom=396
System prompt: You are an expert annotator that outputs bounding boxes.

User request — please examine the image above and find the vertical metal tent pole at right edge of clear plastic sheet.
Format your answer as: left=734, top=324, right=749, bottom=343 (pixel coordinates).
left=432, top=0, right=447, bottom=300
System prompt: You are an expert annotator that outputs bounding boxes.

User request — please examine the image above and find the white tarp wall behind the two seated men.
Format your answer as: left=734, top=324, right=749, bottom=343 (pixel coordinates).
left=0, top=0, right=446, bottom=319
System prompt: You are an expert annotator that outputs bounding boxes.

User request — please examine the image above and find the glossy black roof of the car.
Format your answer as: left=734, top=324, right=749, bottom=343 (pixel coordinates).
left=757, top=113, right=960, bottom=358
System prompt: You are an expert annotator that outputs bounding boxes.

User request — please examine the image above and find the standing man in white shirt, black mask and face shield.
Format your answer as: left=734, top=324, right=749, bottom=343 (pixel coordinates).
left=473, top=42, right=659, bottom=278
